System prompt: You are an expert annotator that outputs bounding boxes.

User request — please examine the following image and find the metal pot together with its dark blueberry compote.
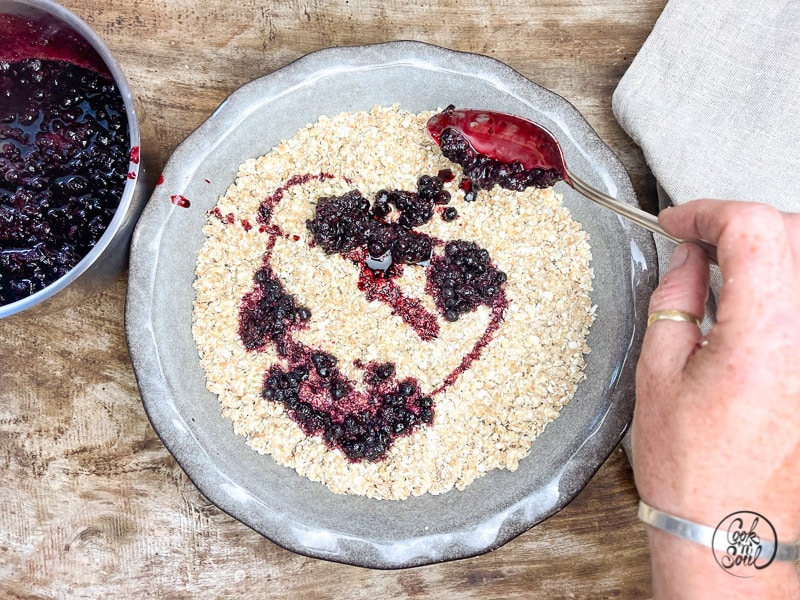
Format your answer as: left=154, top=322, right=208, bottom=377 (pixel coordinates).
left=0, top=0, right=146, bottom=318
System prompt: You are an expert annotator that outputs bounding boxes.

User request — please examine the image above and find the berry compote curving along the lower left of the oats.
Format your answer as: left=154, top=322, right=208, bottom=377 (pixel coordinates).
left=239, top=260, right=434, bottom=461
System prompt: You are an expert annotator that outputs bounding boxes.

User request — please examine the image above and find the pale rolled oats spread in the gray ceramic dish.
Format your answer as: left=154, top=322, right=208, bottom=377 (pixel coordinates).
left=193, top=106, right=595, bottom=499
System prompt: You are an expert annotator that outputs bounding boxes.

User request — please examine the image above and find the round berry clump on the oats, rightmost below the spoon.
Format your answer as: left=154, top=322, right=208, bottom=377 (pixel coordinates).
left=426, top=240, right=506, bottom=322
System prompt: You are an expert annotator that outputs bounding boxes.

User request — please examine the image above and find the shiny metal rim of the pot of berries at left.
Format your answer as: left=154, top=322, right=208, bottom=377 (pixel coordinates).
left=0, top=0, right=141, bottom=319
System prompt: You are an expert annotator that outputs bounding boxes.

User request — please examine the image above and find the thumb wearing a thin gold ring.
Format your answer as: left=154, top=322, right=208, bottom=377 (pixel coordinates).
left=639, top=242, right=709, bottom=381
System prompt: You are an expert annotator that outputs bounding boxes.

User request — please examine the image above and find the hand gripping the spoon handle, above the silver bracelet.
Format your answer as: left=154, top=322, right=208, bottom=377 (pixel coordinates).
left=632, top=200, right=800, bottom=597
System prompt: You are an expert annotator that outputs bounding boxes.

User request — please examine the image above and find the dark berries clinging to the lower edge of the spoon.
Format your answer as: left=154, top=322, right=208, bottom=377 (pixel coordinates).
left=439, top=128, right=561, bottom=199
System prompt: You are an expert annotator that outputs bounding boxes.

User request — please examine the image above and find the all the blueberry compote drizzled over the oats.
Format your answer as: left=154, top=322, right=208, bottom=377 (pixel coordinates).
left=238, top=170, right=508, bottom=461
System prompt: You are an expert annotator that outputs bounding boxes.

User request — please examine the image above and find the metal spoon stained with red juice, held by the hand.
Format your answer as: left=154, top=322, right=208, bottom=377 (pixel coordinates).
left=428, top=106, right=716, bottom=262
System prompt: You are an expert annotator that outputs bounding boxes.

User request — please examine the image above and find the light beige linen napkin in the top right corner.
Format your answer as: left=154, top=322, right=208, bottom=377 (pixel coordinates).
left=613, top=0, right=800, bottom=456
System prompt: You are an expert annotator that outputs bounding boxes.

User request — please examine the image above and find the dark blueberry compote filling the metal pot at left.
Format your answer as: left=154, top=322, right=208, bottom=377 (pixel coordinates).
left=0, top=59, right=130, bottom=305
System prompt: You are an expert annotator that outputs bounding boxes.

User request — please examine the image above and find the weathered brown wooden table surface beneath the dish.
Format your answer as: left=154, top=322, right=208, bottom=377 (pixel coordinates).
left=0, top=0, right=665, bottom=600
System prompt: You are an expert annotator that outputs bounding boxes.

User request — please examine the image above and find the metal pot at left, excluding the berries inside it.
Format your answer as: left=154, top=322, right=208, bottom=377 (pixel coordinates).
left=0, top=0, right=148, bottom=318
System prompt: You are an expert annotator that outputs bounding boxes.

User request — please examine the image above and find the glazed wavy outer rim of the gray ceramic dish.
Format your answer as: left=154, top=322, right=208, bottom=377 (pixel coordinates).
left=125, top=40, right=657, bottom=569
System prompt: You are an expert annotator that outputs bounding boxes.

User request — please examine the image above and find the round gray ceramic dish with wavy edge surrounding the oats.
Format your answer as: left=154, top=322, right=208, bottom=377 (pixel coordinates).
left=126, top=42, right=657, bottom=568
